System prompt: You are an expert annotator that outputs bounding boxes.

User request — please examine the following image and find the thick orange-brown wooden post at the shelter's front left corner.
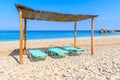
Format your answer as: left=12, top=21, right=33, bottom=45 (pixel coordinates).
left=19, top=10, right=23, bottom=64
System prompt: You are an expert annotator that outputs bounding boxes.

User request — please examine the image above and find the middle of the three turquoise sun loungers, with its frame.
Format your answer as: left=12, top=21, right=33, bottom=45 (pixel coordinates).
left=47, top=47, right=69, bottom=55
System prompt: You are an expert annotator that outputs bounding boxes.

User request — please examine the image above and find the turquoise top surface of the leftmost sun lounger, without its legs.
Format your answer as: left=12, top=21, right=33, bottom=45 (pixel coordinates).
left=28, top=49, right=47, bottom=57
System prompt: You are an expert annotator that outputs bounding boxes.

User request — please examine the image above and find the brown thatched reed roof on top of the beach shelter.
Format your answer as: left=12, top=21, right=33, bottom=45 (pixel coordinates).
left=16, top=4, right=97, bottom=22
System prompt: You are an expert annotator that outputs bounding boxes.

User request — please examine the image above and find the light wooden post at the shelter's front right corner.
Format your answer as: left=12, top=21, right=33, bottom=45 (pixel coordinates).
left=91, top=17, right=94, bottom=55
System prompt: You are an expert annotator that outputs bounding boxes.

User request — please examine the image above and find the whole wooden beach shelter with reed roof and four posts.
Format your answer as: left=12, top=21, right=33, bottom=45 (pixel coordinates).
left=16, top=4, right=97, bottom=64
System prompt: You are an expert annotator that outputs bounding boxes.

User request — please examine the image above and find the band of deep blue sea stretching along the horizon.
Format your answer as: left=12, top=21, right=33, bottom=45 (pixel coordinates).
left=0, top=30, right=120, bottom=42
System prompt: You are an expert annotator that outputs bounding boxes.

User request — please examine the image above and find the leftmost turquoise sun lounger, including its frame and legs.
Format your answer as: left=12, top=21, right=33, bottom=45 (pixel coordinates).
left=28, top=49, right=47, bottom=61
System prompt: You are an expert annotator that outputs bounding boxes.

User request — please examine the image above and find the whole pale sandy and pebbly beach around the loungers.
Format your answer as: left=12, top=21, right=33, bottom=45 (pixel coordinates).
left=0, top=36, right=120, bottom=80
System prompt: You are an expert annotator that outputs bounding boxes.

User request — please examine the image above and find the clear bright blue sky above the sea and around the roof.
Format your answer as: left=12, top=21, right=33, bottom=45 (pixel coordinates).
left=0, top=0, right=120, bottom=30
